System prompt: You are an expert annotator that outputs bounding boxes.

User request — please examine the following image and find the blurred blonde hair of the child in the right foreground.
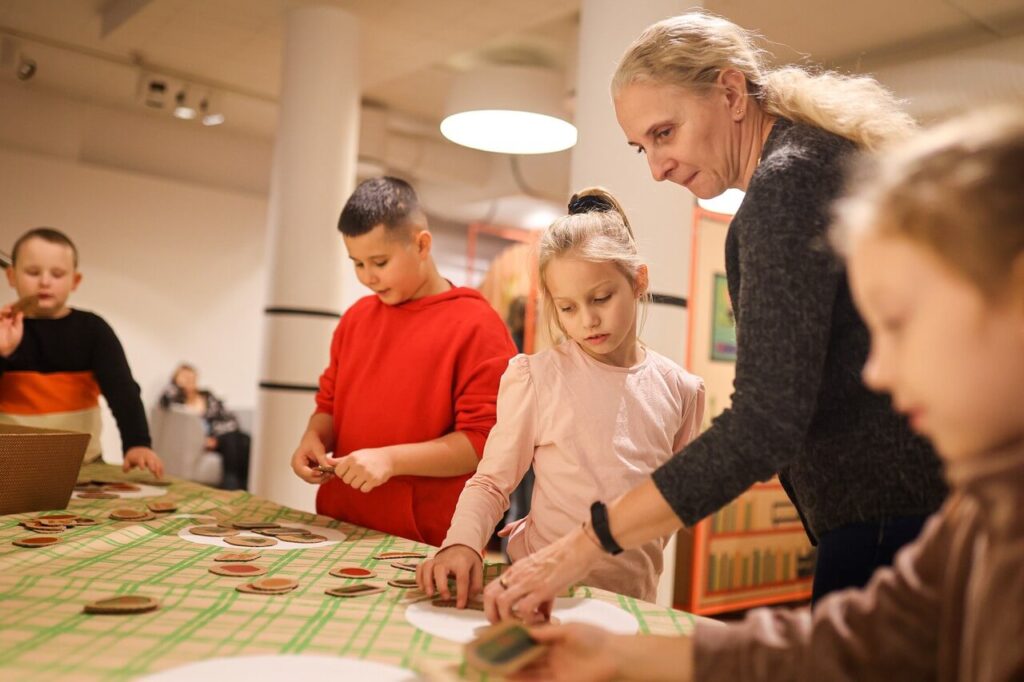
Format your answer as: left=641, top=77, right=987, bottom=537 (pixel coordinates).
left=833, top=105, right=1024, bottom=299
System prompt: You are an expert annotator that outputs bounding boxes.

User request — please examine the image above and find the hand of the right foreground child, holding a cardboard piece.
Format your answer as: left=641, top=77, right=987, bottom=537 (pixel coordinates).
left=513, top=623, right=629, bottom=682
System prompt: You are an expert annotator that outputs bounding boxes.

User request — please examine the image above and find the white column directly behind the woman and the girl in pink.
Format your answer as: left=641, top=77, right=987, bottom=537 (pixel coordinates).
left=570, top=0, right=694, bottom=605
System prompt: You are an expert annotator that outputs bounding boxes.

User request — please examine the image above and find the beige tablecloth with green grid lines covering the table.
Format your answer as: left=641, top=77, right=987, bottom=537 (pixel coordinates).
left=0, top=464, right=694, bottom=680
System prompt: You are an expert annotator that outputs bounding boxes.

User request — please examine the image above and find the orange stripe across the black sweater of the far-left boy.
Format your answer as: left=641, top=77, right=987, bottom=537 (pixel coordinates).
left=0, top=372, right=99, bottom=415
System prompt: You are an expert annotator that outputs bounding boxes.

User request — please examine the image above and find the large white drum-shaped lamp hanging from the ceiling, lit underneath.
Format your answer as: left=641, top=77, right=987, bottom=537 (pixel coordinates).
left=441, top=66, right=577, bottom=154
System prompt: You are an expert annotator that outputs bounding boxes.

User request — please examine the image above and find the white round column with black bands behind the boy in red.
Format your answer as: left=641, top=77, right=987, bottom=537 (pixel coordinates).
left=250, top=5, right=359, bottom=511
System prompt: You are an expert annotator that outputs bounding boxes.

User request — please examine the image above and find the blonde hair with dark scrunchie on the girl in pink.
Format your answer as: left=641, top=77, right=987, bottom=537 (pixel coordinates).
left=538, top=187, right=650, bottom=340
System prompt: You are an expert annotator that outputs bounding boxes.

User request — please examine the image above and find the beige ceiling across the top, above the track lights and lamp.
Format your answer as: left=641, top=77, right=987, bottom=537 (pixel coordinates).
left=0, top=0, right=1024, bottom=132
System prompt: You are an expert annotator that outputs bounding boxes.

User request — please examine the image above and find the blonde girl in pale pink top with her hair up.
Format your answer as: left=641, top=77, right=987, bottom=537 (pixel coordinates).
left=417, top=189, right=703, bottom=607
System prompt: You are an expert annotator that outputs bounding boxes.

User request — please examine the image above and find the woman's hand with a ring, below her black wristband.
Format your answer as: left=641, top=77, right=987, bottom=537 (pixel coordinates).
left=483, top=528, right=602, bottom=623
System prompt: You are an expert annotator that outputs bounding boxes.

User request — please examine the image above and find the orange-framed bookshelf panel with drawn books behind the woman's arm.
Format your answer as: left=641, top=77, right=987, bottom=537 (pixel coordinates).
left=674, top=207, right=814, bottom=615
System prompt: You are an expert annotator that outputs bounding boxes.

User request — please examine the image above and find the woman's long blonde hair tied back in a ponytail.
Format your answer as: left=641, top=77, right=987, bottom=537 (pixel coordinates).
left=611, top=11, right=915, bottom=151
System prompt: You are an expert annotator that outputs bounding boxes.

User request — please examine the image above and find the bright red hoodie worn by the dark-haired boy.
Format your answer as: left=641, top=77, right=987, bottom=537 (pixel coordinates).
left=316, top=287, right=516, bottom=545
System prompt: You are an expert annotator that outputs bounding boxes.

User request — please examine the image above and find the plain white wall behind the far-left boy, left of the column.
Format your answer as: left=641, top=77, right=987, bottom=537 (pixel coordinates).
left=0, top=144, right=266, bottom=461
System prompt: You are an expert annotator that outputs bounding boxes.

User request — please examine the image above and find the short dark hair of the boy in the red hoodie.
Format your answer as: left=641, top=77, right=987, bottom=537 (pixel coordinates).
left=338, top=175, right=425, bottom=237
